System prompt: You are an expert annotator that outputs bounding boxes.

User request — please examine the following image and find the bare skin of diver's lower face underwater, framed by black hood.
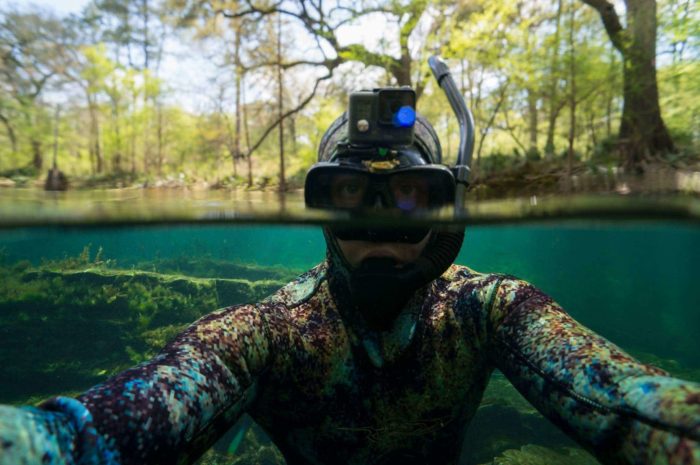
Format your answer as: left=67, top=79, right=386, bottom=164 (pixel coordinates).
left=338, top=234, right=430, bottom=268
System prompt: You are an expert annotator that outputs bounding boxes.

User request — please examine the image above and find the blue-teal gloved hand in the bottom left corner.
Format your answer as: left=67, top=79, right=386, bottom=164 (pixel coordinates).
left=0, top=397, right=118, bottom=465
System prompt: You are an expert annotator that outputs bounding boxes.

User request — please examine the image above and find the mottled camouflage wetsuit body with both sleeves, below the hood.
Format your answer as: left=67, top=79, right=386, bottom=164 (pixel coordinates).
left=0, top=264, right=700, bottom=465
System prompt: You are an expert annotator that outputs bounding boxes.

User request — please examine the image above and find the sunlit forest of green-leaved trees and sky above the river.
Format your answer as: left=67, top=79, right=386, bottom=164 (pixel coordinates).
left=0, top=0, right=700, bottom=190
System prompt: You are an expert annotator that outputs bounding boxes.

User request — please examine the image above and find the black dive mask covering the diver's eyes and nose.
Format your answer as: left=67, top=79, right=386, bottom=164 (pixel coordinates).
left=304, top=144, right=456, bottom=243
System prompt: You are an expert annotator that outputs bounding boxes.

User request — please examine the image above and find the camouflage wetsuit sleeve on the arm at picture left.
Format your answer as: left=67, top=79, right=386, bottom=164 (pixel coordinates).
left=0, top=306, right=270, bottom=465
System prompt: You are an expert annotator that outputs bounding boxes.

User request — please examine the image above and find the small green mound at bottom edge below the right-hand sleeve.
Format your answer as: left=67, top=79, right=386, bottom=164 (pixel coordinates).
left=482, top=444, right=600, bottom=465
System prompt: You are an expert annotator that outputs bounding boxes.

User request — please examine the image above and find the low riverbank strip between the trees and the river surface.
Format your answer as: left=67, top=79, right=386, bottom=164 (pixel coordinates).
left=0, top=157, right=700, bottom=200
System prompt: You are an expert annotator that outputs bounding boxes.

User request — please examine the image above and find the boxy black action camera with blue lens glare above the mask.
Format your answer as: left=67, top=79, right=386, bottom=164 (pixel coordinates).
left=348, top=87, right=416, bottom=147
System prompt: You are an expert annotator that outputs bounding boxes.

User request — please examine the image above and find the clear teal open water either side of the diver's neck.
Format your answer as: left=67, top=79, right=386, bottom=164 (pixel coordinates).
left=0, top=221, right=700, bottom=368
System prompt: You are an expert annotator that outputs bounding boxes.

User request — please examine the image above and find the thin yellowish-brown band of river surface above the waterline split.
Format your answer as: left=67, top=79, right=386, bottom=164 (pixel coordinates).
left=0, top=189, right=700, bottom=227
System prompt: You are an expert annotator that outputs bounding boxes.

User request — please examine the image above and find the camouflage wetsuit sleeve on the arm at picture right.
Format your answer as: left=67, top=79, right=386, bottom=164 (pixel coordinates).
left=489, top=279, right=700, bottom=465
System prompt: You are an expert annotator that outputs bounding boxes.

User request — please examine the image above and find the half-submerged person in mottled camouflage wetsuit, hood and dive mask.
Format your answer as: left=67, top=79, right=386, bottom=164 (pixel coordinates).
left=0, top=59, right=700, bottom=465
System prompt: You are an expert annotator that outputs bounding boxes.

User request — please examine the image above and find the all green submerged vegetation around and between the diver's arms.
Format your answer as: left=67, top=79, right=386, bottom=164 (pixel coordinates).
left=0, top=246, right=700, bottom=465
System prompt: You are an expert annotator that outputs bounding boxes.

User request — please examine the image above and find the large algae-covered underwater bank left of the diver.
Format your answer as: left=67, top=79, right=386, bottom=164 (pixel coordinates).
left=0, top=256, right=288, bottom=403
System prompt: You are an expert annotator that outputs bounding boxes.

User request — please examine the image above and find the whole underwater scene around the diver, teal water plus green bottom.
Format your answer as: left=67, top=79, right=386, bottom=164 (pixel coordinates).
left=0, top=196, right=700, bottom=465
